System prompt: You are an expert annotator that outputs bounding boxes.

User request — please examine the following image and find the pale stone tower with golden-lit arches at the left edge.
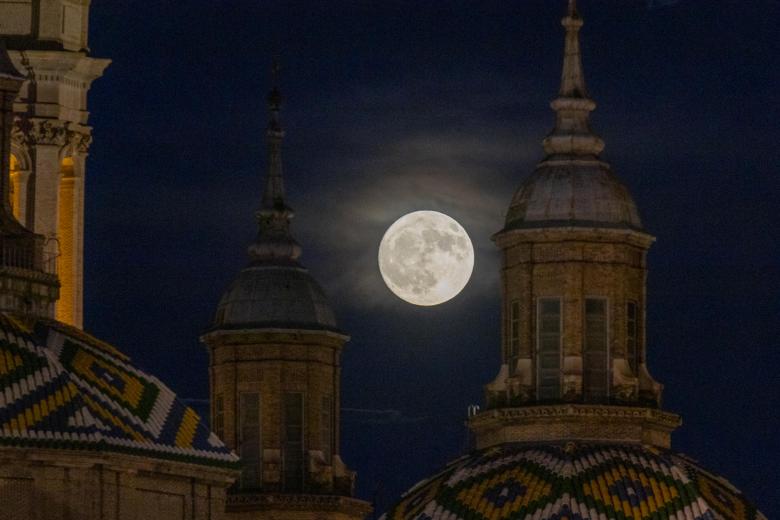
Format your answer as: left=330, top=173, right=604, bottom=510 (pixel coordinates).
left=0, top=0, right=110, bottom=327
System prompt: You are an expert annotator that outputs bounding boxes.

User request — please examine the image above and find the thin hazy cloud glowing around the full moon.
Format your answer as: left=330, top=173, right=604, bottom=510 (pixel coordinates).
left=299, top=132, right=538, bottom=306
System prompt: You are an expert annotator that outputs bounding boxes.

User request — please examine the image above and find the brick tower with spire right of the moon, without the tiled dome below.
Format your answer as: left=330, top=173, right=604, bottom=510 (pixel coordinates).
left=472, top=0, right=679, bottom=446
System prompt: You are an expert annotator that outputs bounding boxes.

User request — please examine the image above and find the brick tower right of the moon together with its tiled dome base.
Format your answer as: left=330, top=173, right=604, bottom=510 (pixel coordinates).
left=380, top=0, right=766, bottom=520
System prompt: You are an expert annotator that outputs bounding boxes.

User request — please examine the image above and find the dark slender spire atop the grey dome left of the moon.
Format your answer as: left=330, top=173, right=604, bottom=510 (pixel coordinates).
left=249, top=60, right=301, bottom=264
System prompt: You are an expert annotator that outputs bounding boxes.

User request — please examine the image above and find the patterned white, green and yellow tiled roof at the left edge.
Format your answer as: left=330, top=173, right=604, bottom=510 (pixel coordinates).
left=0, top=313, right=238, bottom=466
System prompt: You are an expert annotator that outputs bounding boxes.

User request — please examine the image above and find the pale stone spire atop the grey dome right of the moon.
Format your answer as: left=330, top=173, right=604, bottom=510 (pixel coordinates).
left=544, top=0, right=604, bottom=160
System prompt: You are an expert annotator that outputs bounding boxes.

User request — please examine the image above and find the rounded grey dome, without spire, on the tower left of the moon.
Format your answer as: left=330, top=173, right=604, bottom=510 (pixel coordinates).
left=214, top=264, right=337, bottom=331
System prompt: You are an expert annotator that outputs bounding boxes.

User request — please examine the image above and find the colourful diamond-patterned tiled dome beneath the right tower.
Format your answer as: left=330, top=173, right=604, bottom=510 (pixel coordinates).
left=380, top=443, right=766, bottom=520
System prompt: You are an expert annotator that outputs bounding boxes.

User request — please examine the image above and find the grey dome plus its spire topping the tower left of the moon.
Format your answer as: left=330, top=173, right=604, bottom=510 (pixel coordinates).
left=213, top=69, right=338, bottom=331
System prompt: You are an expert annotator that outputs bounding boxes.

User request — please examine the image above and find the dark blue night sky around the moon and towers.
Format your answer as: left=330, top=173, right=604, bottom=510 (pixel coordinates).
left=85, top=0, right=780, bottom=517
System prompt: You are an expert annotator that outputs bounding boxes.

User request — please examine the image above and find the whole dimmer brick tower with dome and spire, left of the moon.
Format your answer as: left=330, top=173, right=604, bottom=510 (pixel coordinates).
left=201, top=68, right=371, bottom=520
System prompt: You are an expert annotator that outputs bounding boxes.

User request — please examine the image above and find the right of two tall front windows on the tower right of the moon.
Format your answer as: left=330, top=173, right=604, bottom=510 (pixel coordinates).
left=583, top=298, right=609, bottom=402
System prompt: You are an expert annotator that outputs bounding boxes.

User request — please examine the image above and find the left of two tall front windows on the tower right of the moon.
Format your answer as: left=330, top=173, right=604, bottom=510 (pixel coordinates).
left=537, top=298, right=561, bottom=401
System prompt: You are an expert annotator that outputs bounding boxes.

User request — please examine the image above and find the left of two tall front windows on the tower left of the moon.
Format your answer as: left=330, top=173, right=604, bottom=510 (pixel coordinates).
left=238, top=392, right=262, bottom=489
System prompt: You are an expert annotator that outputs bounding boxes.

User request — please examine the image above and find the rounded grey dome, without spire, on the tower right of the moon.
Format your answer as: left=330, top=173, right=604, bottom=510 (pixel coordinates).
left=505, top=161, right=642, bottom=230
